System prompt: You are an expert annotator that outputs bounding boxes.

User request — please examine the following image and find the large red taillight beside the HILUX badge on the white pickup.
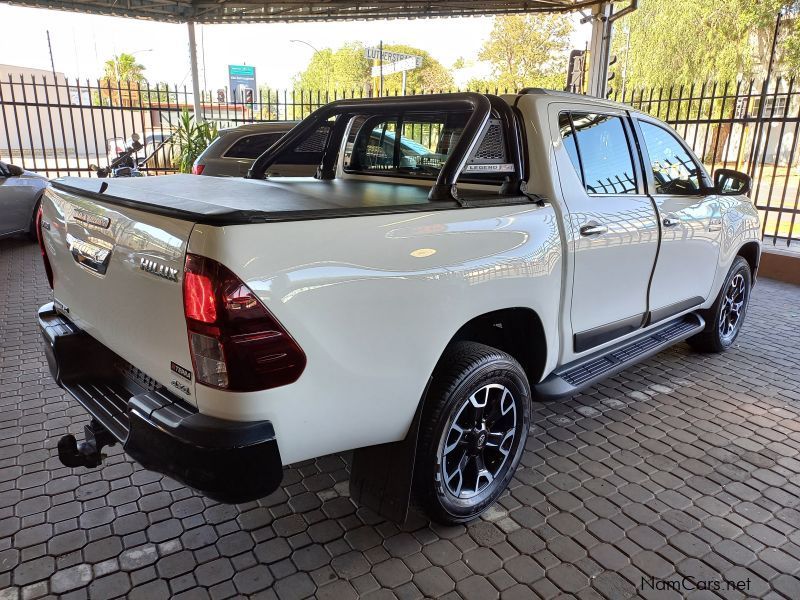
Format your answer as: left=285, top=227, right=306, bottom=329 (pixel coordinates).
left=183, top=254, right=306, bottom=392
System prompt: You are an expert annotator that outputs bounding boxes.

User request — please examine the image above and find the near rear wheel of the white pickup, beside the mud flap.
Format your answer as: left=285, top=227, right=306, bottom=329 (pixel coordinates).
left=415, top=342, right=531, bottom=524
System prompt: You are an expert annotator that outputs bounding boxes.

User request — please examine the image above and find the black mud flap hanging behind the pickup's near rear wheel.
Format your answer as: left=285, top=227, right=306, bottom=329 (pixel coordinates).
left=350, top=379, right=431, bottom=523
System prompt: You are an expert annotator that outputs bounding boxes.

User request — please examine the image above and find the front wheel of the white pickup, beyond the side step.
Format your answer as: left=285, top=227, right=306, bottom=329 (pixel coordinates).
left=687, top=256, right=753, bottom=353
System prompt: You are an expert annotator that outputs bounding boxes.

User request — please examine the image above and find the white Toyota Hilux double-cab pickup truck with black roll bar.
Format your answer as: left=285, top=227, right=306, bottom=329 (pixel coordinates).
left=38, top=89, right=760, bottom=523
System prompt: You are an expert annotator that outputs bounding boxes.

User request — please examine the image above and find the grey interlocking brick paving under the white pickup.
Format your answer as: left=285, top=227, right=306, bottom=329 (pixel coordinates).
left=0, top=240, right=800, bottom=600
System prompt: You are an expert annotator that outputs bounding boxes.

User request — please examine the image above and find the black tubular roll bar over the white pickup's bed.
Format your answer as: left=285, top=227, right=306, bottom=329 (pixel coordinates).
left=246, top=92, right=523, bottom=201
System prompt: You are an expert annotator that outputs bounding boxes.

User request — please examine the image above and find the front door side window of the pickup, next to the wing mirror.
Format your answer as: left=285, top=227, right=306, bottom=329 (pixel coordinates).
left=639, top=121, right=701, bottom=195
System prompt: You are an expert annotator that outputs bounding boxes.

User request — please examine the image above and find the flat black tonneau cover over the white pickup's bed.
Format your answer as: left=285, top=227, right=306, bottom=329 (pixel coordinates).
left=52, top=174, right=530, bottom=225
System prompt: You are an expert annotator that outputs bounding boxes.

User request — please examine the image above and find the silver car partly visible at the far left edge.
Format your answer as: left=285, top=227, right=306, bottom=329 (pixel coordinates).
left=0, top=161, right=49, bottom=240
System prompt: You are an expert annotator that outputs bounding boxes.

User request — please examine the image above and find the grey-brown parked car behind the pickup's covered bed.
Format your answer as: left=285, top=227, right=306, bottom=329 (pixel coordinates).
left=192, top=121, right=308, bottom=177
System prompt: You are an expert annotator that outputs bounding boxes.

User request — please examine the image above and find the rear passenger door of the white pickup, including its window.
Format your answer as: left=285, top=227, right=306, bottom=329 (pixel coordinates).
left=556, top=107, right=658, bottom=353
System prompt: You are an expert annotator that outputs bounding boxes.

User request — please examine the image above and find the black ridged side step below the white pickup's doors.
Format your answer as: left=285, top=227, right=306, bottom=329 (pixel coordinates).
left=533, top=313, right=706, bottom=400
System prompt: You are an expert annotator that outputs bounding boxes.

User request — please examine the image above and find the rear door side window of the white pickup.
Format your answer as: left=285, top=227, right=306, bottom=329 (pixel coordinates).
left=571, top=112, right=637, bottom=194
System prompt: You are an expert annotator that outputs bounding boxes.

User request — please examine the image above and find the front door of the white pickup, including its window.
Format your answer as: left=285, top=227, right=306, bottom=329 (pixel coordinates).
left=636, top=116, right=722, bottom=323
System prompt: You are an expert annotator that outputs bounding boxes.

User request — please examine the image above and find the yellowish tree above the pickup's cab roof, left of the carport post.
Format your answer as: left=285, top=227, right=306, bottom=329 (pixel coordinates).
left=469, top=14, right=572, bottom=90
